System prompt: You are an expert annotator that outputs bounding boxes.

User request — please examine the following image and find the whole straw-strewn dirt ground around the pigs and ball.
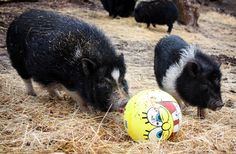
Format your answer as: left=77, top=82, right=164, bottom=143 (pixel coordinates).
left=0, top=0, right=236, bottom=154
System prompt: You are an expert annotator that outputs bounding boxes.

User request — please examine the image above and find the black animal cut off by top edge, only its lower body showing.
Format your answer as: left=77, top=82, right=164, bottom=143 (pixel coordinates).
left=101, top=0, right=135, bottom=18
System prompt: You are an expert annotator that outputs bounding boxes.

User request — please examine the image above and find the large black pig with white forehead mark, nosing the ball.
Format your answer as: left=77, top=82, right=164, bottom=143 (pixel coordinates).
left=7, top=10, right=128, bottom=111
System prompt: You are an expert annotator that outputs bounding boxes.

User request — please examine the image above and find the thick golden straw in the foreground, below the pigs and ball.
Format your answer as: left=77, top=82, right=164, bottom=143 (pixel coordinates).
left=0, top=73, right=236, bottom=153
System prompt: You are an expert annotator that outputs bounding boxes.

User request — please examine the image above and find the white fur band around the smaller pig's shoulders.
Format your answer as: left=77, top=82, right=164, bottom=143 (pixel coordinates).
left=162, top=45, right=196, bottom=96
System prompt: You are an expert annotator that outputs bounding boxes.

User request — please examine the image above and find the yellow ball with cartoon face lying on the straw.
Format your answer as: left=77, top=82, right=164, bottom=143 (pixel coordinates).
left=124, top=90, right=182, bottom=141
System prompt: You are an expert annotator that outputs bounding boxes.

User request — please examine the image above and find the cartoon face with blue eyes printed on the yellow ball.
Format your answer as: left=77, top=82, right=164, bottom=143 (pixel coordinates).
left=142, top=105, right=174, bottom=140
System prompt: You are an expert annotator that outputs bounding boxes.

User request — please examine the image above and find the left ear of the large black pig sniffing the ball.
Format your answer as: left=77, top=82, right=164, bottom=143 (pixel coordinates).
left=82, top=58, right=97, bottom=76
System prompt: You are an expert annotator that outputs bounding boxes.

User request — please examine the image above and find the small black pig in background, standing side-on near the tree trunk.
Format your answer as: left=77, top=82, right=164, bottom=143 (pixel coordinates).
left=134, top=0, right=178, bottom=33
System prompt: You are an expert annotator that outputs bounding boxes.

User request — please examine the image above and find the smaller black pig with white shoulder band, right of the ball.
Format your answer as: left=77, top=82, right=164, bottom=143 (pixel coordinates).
left=154, top=35, right=224, bottom=118
